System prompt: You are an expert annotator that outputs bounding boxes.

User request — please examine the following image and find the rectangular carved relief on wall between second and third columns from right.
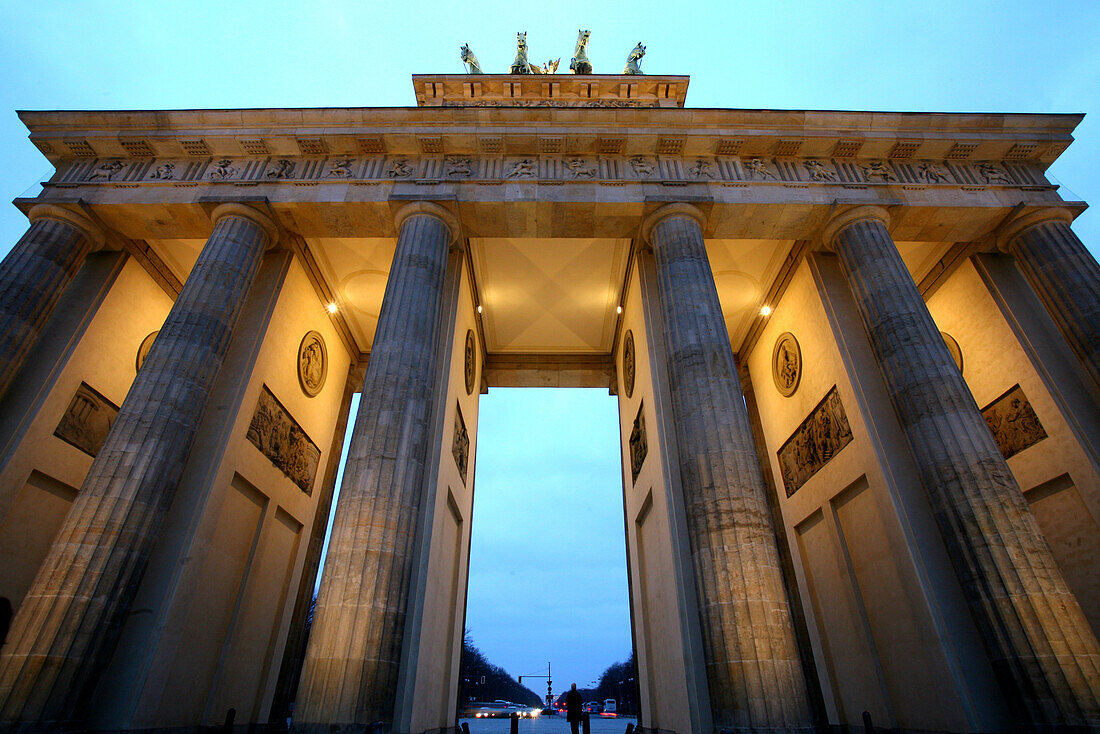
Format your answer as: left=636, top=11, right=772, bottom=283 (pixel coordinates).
left=778, top=385, right=851, bottom=496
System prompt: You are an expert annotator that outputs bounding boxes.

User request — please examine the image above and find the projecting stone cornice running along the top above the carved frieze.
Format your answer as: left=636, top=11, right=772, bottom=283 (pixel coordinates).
left=20, top=107, right=1082, bottom=167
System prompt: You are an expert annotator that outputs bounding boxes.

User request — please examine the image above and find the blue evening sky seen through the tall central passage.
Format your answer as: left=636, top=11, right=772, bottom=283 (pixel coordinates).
left=459, top=388, right=633, bottom=712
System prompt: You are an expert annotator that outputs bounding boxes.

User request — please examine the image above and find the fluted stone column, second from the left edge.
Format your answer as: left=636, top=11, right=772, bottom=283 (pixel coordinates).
left=0, top=204, right=277, bottom=725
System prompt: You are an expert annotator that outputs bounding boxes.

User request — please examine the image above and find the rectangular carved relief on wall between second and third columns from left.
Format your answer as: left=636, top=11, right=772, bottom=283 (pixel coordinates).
left=246, top=385, right=321, bottom=494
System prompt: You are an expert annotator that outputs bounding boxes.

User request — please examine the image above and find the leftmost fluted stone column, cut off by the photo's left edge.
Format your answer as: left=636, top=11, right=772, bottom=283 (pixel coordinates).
left=0, top=204, right=103, bottom=396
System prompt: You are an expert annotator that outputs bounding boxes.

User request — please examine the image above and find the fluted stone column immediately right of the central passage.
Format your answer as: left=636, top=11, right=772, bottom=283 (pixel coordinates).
left=642, top=205, right=811, bottom=731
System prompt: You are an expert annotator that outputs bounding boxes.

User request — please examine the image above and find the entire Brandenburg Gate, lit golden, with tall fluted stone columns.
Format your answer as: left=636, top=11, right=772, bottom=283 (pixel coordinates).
left=0, top=45, right=1100, bottom=734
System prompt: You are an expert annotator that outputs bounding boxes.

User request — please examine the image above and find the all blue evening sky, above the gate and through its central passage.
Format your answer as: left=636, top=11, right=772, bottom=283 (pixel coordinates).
left=0, top=0, right=1100, bottom=690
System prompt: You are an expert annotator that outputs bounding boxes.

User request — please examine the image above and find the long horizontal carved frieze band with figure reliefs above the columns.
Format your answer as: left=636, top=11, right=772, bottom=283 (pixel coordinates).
left=52, top=151, right=1049, bottom=188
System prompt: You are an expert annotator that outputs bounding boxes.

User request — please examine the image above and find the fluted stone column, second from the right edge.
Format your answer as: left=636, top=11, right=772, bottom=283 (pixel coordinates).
left=824, top=207, right=1100, bottom=727
